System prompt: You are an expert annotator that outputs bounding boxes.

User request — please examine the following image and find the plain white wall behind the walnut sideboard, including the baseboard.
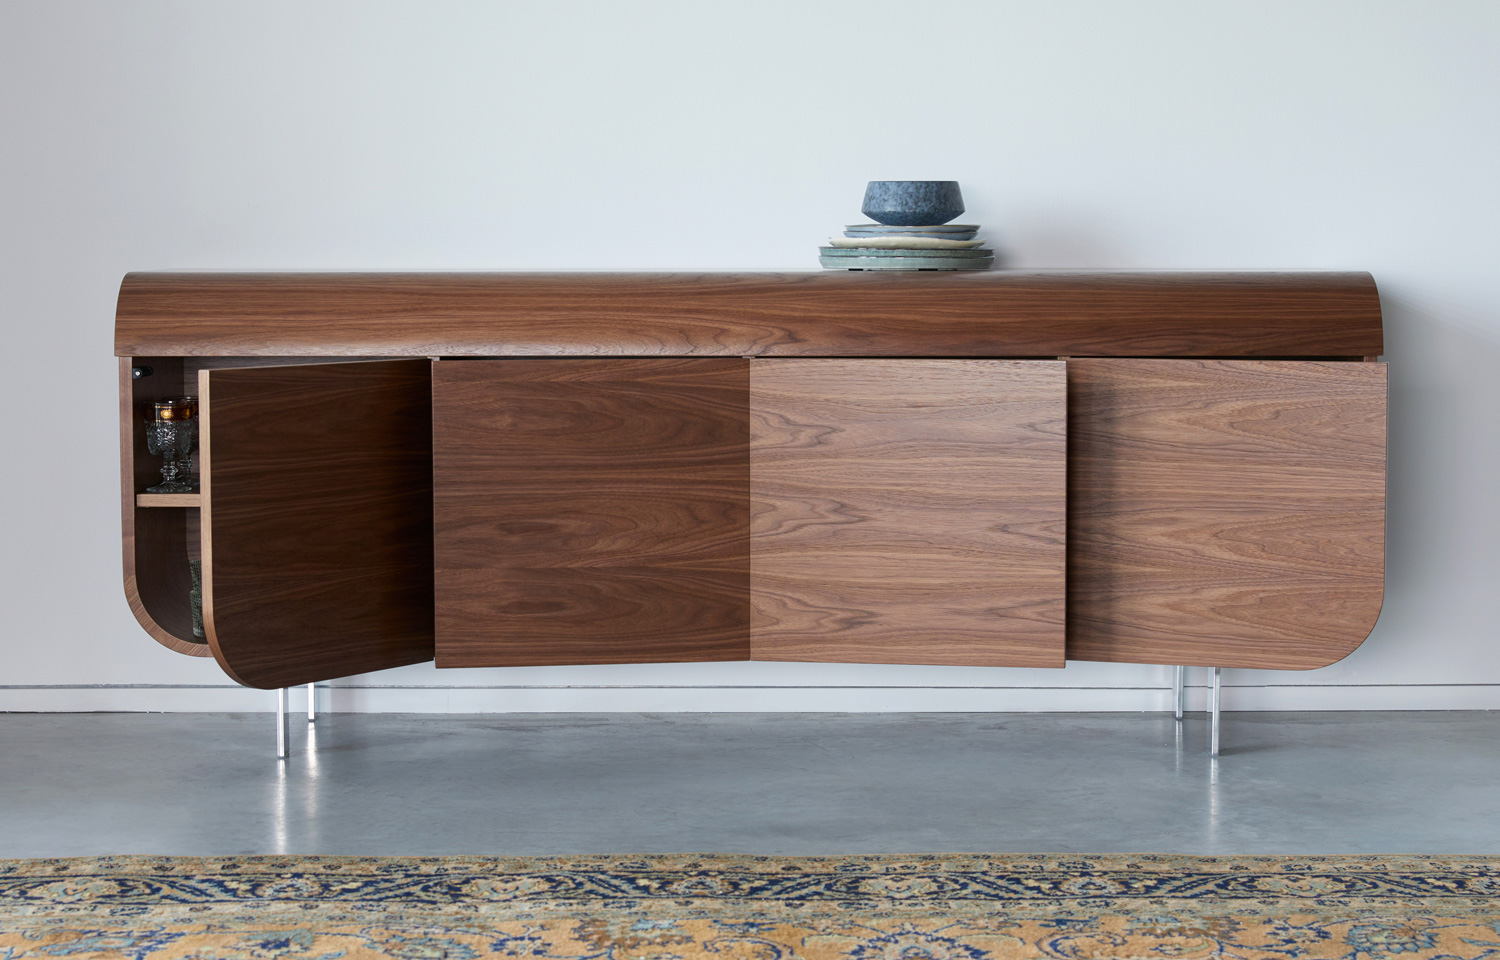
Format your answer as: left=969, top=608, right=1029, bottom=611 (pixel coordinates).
left=0, top=0, right=1500, bottom=711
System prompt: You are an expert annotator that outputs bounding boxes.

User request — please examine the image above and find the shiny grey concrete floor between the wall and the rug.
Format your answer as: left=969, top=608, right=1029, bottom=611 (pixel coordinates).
left=0, top=713, right=1500, bottom=857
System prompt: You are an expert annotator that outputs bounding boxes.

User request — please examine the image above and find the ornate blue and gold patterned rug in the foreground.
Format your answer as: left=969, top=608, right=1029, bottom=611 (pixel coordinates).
left=0, top=855, right=1500, bottom=960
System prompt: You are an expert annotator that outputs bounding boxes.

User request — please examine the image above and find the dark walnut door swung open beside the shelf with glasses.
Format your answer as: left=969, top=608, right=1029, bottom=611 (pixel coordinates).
left=198, top=360, right=432, bottom=689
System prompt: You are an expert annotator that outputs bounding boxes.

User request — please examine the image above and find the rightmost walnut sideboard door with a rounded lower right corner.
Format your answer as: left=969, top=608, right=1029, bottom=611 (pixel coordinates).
left=1068, top=360, right=1386, bottom=669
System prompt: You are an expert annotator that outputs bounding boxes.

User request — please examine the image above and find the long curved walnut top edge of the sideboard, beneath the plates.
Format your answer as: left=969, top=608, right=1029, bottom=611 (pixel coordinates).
left=114, top=272, right=1383, bottom=357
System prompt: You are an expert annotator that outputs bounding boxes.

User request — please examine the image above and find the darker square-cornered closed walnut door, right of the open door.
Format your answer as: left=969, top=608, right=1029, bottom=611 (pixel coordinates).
left=432, top=359, right=750, bottom=668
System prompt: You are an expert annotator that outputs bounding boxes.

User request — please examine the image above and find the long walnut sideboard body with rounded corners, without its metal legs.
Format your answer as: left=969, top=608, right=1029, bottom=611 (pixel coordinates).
left=116, top=272, right=1386, bottom=689
